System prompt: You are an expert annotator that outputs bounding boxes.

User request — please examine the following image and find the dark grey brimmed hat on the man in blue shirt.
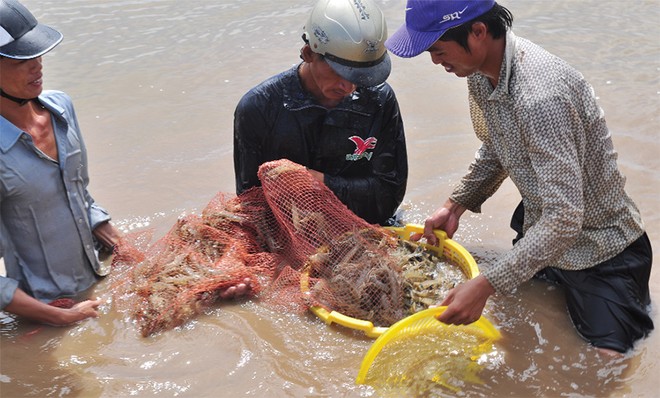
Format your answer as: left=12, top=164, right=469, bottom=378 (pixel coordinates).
left=0, top=0, right=62, bottom=59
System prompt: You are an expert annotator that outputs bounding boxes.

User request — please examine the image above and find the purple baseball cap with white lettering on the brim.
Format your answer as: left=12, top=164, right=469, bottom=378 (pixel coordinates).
left=385, top=0, right=495, bottom=58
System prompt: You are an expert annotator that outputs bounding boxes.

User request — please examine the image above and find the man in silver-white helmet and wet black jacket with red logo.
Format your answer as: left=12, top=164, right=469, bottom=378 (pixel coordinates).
left=234, top=0, right=408, bottom=224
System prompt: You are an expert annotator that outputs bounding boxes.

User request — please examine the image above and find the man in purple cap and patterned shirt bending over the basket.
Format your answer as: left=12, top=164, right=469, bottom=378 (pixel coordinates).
left=386, top=0, right=653, bottom=353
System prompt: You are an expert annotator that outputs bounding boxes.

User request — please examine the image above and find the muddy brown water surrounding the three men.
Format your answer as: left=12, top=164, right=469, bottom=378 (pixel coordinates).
left=0, top=0, right=660, bottom=397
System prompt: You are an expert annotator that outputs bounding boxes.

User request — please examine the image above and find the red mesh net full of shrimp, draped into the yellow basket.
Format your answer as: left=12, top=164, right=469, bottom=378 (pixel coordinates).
left=113, top=160, right=466, bottom=336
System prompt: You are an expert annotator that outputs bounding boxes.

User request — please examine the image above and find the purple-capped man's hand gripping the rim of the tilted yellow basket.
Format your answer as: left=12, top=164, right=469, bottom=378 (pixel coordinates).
left=438, top=275, right=495, bottom=325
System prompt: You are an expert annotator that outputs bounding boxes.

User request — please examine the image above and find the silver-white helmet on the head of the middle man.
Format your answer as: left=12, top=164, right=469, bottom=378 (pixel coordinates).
left=303, top=0, right=392, bottom=87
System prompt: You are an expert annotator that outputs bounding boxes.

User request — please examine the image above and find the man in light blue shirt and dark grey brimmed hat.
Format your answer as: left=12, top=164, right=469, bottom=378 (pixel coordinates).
left=0, top=0, right=119, bottom=325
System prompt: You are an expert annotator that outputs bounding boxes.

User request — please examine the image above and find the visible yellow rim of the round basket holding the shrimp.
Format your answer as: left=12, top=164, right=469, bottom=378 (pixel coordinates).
left=300, top=224, right=479, bottom=338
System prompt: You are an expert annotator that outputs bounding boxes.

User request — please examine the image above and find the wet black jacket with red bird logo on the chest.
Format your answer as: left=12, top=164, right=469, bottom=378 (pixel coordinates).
left=234, top=66, right=408, bottom=224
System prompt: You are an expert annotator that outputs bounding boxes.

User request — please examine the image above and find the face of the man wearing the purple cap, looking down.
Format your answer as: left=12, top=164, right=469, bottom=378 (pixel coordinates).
left=426, top=38, right=483, bottom=77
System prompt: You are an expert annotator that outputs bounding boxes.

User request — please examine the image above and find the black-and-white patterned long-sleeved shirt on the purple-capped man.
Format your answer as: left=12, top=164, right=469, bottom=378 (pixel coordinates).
left=451, top=31, right=644, bottom=292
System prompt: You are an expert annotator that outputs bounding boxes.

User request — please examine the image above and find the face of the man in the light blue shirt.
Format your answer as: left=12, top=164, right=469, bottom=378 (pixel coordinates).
left=0, top=57, right=43, bottom=98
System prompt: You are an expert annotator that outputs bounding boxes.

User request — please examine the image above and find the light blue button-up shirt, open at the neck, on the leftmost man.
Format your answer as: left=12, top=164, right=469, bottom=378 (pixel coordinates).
left=0, top=91, right=110, bottom=309
